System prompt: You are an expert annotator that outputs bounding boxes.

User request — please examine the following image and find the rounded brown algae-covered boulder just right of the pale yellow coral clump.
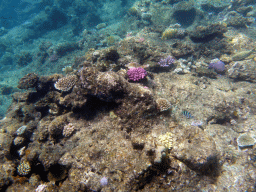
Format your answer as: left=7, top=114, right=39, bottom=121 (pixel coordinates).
left=171, top=126, right=218, bottom=174
